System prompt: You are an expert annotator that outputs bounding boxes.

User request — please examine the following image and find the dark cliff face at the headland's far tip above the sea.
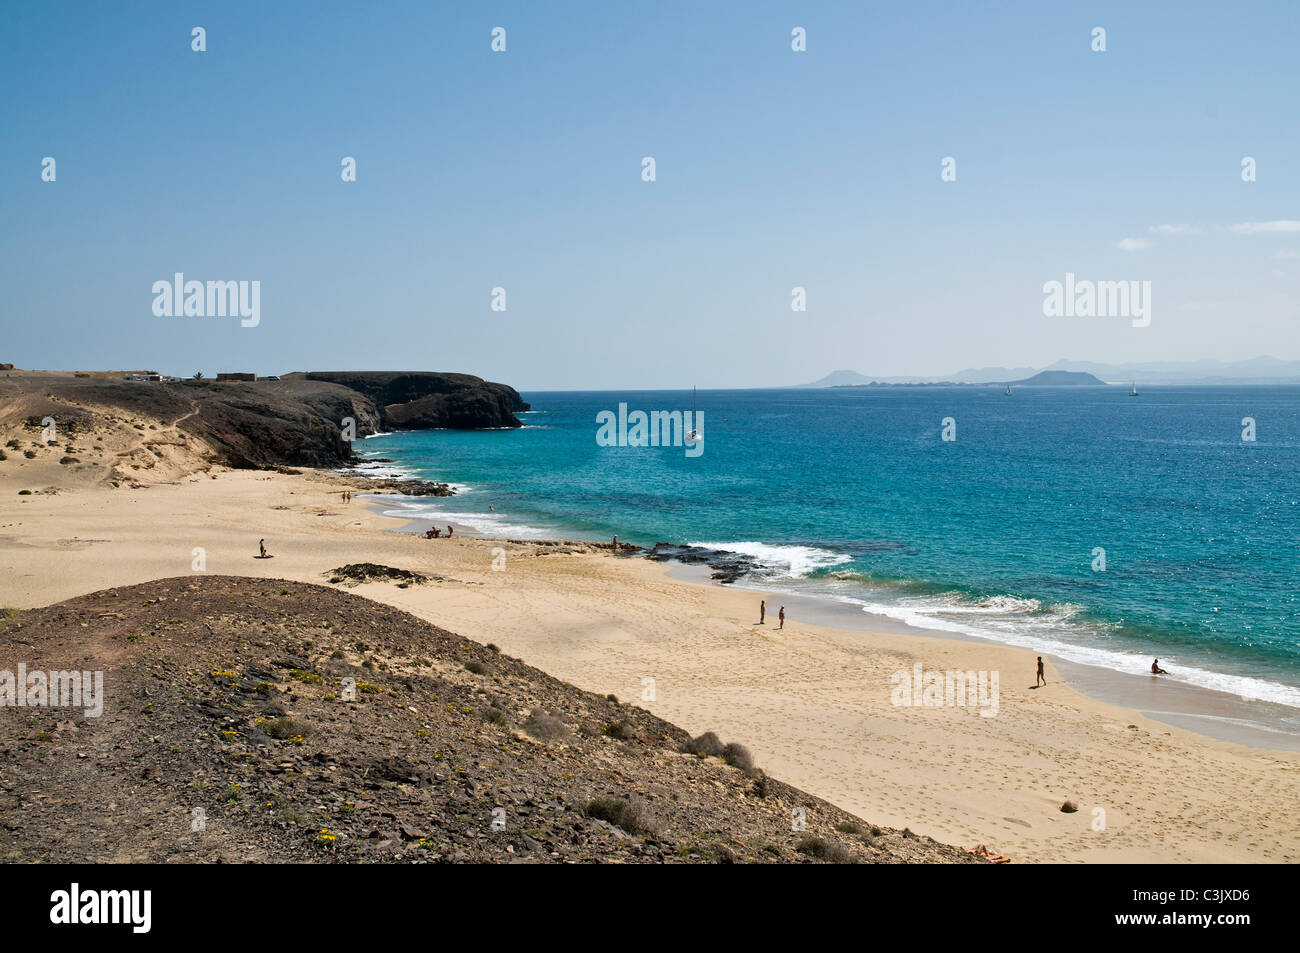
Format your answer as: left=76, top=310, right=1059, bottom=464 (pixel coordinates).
left=297, top=371, right=528, bottom=430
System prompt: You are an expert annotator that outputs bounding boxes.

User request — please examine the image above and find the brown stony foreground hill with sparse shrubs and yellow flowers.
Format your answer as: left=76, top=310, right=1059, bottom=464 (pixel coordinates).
left=0, top=567, right=975, bottom=863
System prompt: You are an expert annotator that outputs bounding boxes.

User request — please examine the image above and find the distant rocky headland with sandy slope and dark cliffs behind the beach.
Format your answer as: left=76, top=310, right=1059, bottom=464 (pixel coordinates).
left=0, top=371, right=528, bottom=478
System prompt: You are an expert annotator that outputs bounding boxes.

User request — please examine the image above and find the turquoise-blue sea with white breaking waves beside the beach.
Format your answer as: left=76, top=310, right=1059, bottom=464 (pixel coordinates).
left=359, top=387, right=1300, bottom=707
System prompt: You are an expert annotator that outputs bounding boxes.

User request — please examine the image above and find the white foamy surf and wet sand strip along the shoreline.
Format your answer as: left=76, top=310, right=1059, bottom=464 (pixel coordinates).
left=351, top=439, right=1300, bottom=722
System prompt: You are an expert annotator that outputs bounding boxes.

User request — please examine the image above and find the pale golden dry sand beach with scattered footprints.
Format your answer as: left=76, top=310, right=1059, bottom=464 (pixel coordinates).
left=0, top=459, right=1300, bottom=863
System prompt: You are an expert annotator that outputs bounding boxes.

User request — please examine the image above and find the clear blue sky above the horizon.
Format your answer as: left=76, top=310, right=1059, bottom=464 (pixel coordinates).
left=0, top=0, right=1300, bottom=390
